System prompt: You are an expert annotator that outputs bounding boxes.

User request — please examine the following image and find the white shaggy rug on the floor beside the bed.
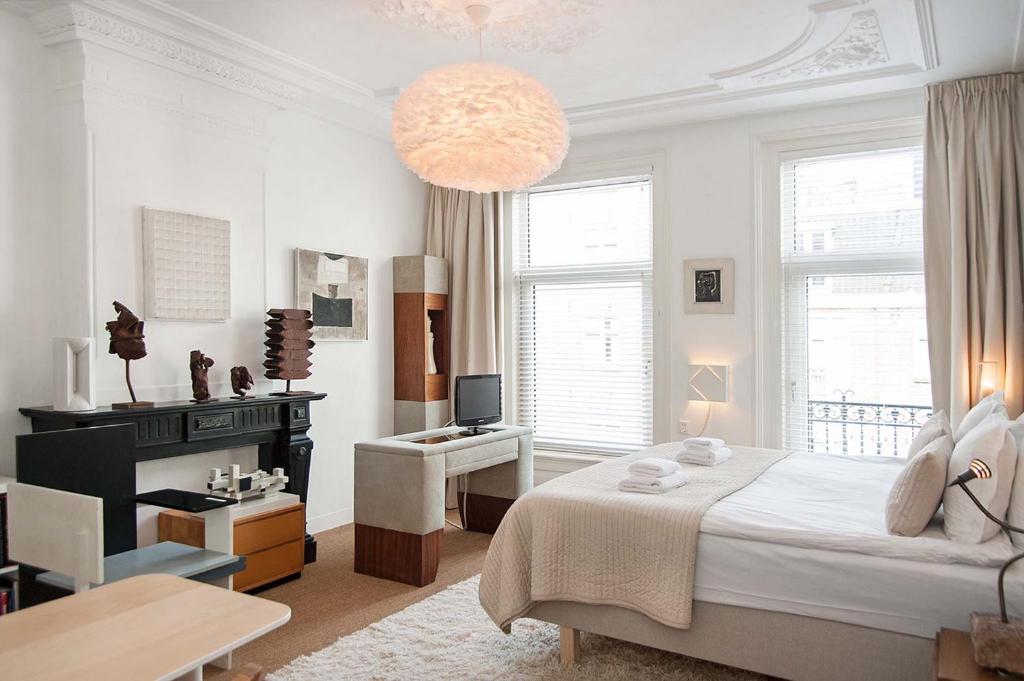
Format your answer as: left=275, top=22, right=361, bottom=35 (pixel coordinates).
left=268, top=577, right=766, bottom=681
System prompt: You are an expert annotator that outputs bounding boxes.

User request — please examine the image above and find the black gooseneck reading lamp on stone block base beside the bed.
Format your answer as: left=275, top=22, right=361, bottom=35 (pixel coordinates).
left=949, top=459, right=1024, bottom=674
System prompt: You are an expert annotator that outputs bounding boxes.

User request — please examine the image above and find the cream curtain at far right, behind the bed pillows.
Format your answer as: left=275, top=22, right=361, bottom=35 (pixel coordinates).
left=925, top=74, right=1024, bottom=424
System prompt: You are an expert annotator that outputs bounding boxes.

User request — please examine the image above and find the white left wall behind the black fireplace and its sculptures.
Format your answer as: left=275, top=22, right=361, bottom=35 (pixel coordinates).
left=0, top=11, right=426, bottom=543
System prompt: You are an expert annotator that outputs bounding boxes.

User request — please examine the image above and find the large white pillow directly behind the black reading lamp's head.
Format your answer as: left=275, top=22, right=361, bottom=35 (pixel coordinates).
left=942, top=414, right=1017, bottom=544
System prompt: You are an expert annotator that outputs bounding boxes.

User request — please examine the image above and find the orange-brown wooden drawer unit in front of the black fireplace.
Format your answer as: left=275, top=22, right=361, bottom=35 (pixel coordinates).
left=157, top=503, right=305, bottom=591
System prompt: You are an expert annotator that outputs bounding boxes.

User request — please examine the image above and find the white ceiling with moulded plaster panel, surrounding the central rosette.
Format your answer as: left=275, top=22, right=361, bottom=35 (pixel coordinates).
left=9, top=0, right=1024, bottom=134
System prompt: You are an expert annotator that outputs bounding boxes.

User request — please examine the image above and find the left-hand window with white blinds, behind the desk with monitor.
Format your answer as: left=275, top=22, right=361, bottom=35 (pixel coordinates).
left=513, top=177, right=653, bottom=454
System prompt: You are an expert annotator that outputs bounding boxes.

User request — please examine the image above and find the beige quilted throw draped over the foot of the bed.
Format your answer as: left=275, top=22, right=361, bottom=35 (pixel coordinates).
left=480, top=442, right=786, bottom=632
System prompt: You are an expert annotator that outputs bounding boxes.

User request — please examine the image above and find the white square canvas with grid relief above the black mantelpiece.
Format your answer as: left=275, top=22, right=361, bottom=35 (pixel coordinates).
left=142, top=208, right=231, bottom=322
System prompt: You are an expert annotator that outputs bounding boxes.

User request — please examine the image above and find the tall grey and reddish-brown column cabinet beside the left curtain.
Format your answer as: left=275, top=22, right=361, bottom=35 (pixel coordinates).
left=393, top=255, right=450, bottom=433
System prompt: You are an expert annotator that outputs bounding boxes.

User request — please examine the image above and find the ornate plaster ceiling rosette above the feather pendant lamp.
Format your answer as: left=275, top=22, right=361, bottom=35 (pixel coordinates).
left=372, top=0, right=603, bottom=53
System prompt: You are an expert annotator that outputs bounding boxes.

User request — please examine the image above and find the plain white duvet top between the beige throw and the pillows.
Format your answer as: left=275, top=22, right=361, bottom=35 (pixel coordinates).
left=700, top=448, right=1013, bottom=566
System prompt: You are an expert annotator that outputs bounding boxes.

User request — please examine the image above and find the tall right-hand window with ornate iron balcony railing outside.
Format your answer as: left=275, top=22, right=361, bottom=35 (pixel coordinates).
left=779, top=144, right=931, bottom=456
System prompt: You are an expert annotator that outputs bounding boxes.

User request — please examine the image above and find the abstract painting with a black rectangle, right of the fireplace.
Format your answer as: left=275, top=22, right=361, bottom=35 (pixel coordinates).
left=295, top=248, right=369, bottom=341
